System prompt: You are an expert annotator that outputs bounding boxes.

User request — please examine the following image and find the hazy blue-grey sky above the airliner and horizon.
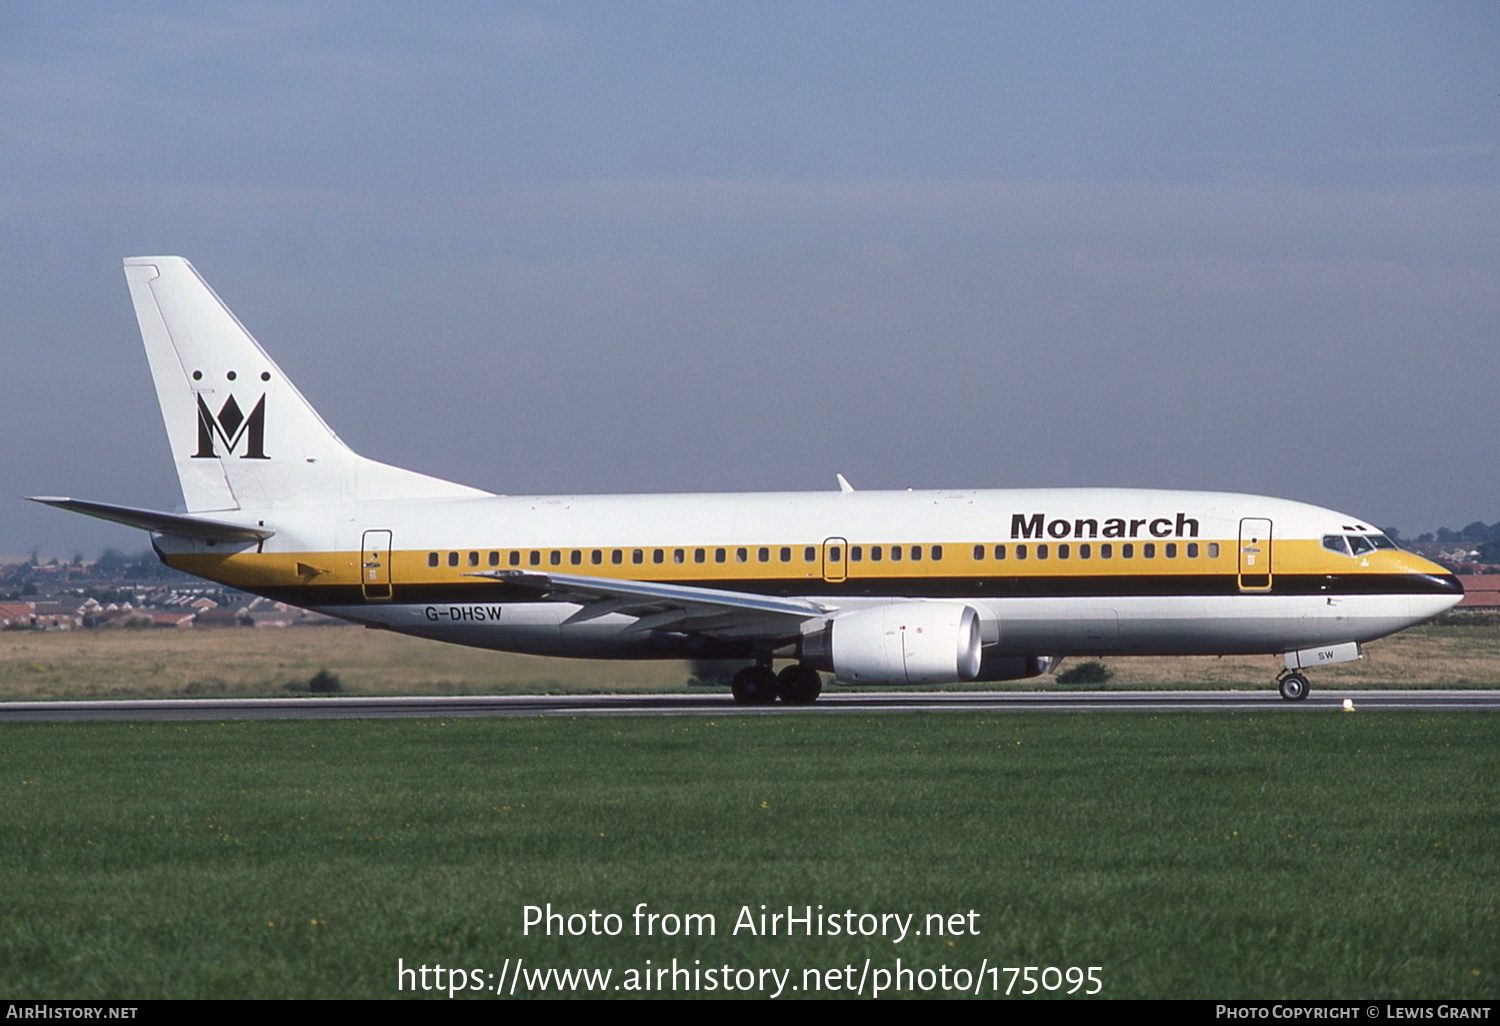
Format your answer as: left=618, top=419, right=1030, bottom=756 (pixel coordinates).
left=0, top=2, right=1500, bottom=557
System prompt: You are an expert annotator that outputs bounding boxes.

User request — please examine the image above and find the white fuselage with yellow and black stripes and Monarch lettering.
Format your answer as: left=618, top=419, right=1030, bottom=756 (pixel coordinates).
left=159, top=489, right=1458, bottom=657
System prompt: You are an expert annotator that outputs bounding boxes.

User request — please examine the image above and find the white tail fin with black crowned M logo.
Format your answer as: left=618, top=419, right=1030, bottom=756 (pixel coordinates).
left=125, top=257, right=489, bottom=513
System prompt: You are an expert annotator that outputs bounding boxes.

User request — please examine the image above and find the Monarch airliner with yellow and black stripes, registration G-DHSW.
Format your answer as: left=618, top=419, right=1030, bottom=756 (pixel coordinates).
left=36, top=257, right=1463, bottom=704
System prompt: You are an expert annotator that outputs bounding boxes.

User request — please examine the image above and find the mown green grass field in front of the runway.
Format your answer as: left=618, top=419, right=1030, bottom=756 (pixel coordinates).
left=0, top=710, right=1500, bottom=999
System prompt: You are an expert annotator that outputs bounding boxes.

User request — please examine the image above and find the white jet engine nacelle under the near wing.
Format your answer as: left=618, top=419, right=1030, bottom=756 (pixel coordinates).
left=828, top=602, right=981, bottom=684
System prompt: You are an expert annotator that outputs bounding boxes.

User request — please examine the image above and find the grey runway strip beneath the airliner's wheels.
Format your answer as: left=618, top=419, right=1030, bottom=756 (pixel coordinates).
left=0, top=689, right=1500, bottom=723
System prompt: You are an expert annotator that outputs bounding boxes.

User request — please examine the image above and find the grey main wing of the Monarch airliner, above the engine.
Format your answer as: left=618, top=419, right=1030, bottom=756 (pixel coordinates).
left=465, top=570, right=834, bottom=638
